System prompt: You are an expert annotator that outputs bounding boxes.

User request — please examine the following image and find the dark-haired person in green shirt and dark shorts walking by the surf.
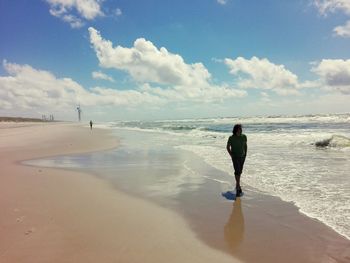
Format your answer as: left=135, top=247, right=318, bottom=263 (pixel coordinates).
left=226, top=124, right=248, bottom=196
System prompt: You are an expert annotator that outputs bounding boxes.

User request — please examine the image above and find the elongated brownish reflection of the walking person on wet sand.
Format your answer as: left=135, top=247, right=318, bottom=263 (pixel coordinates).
left=224, top=198, right=244, bottom=252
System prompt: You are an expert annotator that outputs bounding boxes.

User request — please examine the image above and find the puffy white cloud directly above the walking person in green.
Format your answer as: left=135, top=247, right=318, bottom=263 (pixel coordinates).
left=225, top=57, right=300, bottom=95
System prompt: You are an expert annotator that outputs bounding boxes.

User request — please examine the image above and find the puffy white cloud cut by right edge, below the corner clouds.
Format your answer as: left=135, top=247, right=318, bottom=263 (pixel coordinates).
left=312, top=59, right=350, bottom=94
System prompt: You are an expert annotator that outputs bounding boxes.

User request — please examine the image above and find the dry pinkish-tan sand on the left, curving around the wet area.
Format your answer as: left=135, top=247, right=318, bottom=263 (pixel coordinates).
left=0, top=123, right=239, bottom=263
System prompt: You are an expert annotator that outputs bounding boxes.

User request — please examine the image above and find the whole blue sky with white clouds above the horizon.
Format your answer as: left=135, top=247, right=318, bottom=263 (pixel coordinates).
left=0, top=0, right=350, bottom=121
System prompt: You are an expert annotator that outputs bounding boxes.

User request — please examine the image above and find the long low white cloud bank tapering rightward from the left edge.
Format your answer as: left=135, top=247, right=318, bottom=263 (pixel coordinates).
left=0, top=55, right=246, bottom=119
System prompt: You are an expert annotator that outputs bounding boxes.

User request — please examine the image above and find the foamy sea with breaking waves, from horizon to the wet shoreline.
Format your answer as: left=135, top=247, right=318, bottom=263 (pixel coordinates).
left=107, top=114, right=350, bottom=239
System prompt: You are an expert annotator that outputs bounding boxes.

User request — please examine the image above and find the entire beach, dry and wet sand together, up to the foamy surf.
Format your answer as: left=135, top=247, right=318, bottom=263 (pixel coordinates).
left=0, top=124, right=350, bottom=262
